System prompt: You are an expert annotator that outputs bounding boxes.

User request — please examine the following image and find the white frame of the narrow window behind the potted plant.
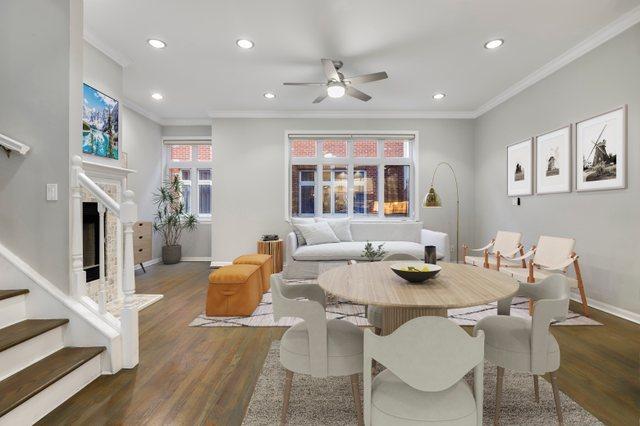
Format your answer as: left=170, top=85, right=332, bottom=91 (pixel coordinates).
left=162, top=136, right=213, bottom=223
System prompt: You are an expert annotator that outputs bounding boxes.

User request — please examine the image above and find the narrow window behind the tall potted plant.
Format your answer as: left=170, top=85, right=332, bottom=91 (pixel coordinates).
left=165, top=142, right=213, bottom=220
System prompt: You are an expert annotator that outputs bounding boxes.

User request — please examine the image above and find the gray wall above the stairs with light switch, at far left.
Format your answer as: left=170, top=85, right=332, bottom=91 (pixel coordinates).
left=0, top=0, right=82, bottom=291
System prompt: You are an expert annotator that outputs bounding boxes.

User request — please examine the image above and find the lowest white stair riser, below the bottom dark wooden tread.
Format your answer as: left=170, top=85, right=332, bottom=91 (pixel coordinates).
left=0, top=355, right=101, bottom=426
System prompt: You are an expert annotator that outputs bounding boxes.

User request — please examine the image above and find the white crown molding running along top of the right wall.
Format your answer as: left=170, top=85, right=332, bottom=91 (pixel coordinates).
left=473, top=6, right=640, bottom=118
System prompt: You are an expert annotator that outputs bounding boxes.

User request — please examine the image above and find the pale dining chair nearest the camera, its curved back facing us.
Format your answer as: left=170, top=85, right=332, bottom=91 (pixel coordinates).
left=363, top=317, right=484, bottom=426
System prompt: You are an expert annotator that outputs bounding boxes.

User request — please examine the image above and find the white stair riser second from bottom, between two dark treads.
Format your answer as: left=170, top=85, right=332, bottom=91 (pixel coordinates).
left=0, top=327, right=64, bottom=380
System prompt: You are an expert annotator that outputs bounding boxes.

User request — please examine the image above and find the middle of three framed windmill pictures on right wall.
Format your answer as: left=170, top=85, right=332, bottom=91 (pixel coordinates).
left=536, top=125, right=572, bottom=194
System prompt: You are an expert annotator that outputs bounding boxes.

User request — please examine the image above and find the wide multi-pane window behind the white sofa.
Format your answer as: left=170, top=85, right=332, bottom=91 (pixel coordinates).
left=287, top=134, right=416, bottom=219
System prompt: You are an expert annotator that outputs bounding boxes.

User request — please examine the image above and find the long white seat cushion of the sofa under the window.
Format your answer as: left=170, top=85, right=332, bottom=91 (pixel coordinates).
left=293, top=241, right=442, bottom=261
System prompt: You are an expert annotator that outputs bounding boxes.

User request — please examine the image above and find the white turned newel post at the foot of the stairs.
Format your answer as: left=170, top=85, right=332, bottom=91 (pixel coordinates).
left=120, top=190, right=139, bottom=368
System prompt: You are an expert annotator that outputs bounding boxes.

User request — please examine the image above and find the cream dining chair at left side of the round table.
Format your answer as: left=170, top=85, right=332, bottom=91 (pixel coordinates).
left=271, top=274, right=363, bottom=425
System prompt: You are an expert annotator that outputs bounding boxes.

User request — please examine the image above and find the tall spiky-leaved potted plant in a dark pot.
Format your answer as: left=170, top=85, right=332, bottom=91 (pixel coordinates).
left=153, top=175, right=198, bottom=264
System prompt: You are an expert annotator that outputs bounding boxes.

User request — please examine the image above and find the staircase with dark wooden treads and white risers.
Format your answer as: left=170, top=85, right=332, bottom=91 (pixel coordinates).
left=0, top=290, right=105, bottom=426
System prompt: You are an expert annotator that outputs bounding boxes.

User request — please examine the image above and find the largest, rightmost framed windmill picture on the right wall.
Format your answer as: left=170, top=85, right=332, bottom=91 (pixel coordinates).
left=576, top=105, right=627, bottom=191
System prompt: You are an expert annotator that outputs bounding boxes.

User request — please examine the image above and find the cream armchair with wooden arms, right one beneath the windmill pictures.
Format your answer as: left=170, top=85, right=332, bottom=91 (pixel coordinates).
left=500, top=235, right=589, bottom=317
